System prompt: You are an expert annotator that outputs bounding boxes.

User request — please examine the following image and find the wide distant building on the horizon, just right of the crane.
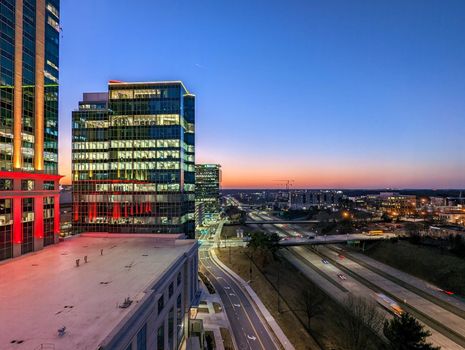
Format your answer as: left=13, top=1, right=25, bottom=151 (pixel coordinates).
left=291, top=190, right=343, bottom=209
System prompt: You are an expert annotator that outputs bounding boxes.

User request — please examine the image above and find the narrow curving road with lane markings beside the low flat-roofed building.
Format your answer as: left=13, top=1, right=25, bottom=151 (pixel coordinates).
left=199, top=226, right=280, bottom=350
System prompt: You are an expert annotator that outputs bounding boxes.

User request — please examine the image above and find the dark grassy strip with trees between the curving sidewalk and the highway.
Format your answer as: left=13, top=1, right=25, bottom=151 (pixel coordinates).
left=217, top=248, right=378, bottom=350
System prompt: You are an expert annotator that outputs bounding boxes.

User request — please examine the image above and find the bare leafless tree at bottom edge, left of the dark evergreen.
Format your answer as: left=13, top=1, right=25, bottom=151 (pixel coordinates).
left=337, top=294, right=383, bottom=350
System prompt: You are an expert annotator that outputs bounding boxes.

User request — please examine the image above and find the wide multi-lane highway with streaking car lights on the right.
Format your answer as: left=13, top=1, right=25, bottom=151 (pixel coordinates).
left=251, top=213, right=465, bottom=349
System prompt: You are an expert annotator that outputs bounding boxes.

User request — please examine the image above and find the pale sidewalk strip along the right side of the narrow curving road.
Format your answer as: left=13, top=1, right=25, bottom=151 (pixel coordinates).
left=210, top=249, right=295, bottom=350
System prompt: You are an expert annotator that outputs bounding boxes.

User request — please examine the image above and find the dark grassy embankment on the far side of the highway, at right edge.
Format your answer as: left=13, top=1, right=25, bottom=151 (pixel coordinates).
left=365, top=241, right=465, bottom=296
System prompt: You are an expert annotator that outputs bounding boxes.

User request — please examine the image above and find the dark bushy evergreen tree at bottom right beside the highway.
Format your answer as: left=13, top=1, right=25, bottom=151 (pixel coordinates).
left=383, top=313, right=440, bottom=350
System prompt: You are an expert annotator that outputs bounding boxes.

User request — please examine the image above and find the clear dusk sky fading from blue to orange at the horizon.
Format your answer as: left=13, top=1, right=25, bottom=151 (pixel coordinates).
left=60, top=0, right=465, bottom=188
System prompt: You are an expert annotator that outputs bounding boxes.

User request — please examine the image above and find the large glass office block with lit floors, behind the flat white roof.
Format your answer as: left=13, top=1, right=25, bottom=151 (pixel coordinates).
left=73, top=81, right=195, bottom=237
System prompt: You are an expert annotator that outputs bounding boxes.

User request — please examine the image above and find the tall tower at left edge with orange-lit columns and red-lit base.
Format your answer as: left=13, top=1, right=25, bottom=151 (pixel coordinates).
left=0, top=0, right=60, bottom=260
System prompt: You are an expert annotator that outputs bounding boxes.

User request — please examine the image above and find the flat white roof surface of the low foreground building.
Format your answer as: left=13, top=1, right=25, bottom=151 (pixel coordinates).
left=0, top=235, right=195, bottom=350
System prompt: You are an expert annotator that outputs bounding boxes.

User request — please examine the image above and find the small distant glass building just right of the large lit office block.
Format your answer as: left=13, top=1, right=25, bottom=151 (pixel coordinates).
left=195, top=164, right=221, bottom=225
